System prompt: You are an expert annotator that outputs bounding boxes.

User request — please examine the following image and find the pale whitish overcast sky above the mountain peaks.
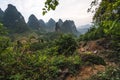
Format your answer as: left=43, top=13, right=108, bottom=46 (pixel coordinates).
left=0, top=0, right=93, bottom=26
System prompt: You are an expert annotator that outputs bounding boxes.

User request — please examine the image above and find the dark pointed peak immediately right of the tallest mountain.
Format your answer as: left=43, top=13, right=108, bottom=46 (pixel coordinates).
left=27, top=14, right=42, bottom=30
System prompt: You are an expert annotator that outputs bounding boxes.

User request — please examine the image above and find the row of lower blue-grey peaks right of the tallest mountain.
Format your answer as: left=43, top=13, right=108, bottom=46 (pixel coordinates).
left=27, top=16, right=78, bottom=35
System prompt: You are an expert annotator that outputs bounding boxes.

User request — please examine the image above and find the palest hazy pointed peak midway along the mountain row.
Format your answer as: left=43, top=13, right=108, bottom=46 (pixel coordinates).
left=46, top=18, right=56, bottom=32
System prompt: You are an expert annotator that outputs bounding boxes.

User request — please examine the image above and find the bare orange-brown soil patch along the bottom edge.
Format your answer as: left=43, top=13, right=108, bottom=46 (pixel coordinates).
left=66, top=65, right=105, bottom=80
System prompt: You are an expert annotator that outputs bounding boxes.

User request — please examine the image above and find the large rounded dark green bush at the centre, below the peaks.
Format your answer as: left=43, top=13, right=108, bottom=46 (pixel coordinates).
left=55, top=35, right=78, bottom=55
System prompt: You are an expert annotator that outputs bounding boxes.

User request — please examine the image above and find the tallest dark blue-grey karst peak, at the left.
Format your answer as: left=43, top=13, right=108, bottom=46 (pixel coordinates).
left=3, top=4, right=29, bottom=33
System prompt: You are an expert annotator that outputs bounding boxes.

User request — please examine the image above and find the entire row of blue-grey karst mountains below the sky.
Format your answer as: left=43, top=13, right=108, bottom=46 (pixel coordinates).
left=0, top=4, right=89, bottom=35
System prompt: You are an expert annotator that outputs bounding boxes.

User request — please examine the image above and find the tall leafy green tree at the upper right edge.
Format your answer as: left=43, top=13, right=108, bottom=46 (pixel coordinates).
left=93, top=0, right=120, bottom=35
